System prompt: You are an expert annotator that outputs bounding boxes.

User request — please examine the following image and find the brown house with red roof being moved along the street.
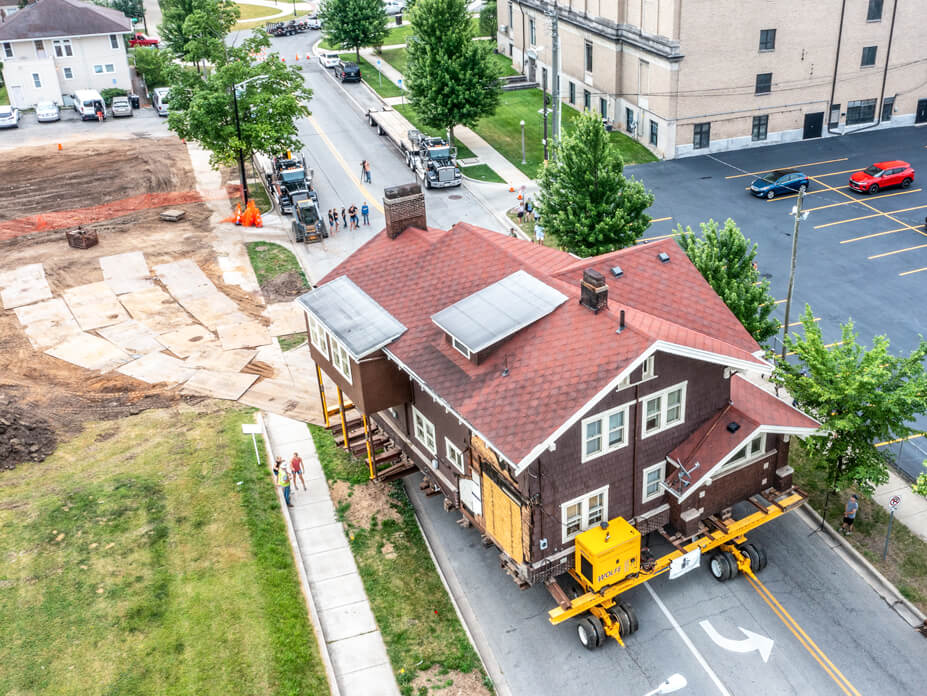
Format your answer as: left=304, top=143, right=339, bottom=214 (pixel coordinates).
left=299, top=184, right=818, bottom=583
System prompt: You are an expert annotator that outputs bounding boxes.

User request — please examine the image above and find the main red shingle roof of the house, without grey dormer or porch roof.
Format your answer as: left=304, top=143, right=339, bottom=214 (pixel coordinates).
left=319, top=223, right=767, bottom=464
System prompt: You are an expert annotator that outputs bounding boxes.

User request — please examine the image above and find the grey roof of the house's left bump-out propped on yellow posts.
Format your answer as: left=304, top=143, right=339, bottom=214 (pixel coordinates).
left=296, top=276, right=406, bottom=360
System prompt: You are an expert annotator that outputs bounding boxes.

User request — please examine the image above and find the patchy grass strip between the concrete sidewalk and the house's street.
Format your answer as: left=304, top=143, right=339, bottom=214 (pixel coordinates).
left=309, top=426, right=492, bottom=696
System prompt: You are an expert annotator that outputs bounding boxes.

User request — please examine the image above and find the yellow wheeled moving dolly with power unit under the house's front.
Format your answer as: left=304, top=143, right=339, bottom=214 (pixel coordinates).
left=547, top=487, right=808, bottom=650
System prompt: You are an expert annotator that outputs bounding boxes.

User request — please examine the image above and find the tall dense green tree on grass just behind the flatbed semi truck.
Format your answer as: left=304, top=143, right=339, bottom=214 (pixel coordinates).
left=406, top=0, right=502, bottom=142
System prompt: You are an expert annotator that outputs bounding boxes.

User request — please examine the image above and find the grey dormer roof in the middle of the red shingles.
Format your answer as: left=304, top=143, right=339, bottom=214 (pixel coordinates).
left=431, top=271, right=567, bottom=353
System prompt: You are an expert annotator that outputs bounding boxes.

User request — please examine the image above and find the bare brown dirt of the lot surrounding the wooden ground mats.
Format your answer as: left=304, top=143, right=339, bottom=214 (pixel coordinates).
left=0, top=138, right=263, bottom=468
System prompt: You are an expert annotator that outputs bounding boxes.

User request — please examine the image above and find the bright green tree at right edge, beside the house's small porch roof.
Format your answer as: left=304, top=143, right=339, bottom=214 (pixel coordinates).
left=773, top=305, right=927, bottom=502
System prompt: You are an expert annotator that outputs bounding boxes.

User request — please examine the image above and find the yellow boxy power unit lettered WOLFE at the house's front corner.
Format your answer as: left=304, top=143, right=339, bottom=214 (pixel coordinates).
left=575, top=517, right=641, bottom=592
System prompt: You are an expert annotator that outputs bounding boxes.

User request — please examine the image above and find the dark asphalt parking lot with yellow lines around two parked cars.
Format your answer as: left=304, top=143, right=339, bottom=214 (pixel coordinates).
left=626, top=127, right=927, bottom=474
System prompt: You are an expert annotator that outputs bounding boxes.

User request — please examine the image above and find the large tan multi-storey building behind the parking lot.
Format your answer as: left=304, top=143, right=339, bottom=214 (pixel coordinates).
left=498, top=0, right=927, bottom=159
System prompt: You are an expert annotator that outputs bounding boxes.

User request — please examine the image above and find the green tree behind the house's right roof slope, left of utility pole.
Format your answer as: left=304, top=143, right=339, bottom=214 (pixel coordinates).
left=676, top=218, right=780, bottom=343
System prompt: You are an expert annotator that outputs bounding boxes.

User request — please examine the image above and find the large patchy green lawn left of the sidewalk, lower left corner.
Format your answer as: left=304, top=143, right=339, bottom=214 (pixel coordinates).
left=0, top=402, right=328, bottom=696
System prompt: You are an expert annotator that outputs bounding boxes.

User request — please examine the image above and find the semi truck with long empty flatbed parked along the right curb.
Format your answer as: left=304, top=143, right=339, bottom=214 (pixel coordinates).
left=367, top=107, right=463, bottom=188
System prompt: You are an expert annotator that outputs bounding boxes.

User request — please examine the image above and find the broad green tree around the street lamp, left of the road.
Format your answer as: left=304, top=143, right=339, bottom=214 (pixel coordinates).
left=167, top=33, right=312, bottom=166
